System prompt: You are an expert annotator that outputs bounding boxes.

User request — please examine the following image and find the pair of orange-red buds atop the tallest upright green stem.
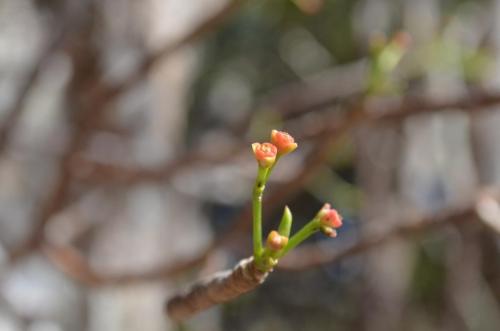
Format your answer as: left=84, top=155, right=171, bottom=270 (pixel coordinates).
left=252, top=130, right=297, bottom=168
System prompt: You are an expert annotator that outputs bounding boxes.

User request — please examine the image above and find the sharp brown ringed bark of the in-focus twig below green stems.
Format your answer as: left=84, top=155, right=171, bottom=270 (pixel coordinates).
left=166, top=258, right=268, bottom=321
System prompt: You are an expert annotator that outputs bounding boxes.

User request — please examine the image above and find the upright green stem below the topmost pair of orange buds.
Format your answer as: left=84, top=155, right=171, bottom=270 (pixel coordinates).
left=252, top=167, right=269, bottom=264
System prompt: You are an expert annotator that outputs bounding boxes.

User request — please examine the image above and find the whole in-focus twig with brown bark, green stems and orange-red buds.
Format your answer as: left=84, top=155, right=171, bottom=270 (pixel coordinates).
left=166, top=130, right=342, bottom=321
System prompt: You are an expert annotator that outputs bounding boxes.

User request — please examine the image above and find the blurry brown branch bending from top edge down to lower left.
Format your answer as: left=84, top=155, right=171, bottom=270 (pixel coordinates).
left=6, top=0, right=244, bottom=262
